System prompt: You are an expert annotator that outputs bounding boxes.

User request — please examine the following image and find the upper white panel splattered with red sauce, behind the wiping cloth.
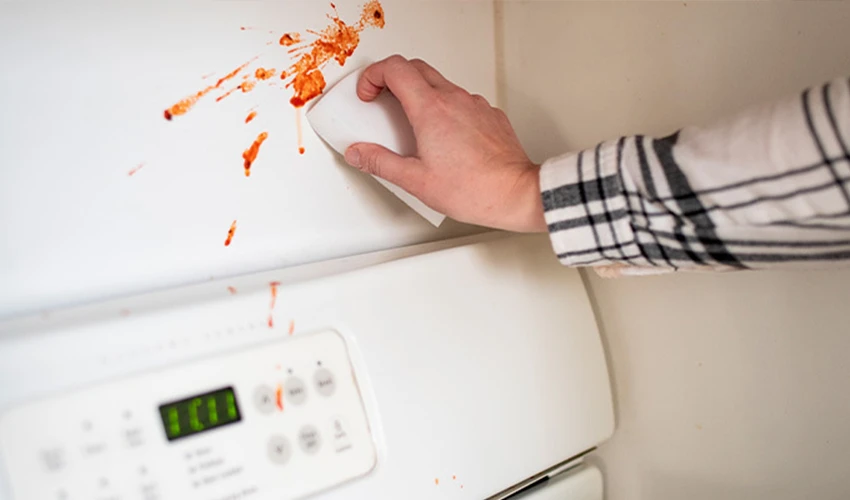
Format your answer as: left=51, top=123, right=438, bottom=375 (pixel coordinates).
left=0, top=0, right=496, bottom=318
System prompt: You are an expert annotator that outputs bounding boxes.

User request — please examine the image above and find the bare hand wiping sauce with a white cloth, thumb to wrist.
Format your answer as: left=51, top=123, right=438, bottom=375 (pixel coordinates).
left=345, top=55, right=546, bottom=232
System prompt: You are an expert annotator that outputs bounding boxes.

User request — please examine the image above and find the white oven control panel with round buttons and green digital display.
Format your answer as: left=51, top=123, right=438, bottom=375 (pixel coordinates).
left=0, top=330, right=376, bottom=500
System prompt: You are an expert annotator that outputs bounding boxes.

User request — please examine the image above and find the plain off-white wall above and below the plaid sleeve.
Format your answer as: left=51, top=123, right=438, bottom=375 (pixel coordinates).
left=500, top=2, right=850, bottom=500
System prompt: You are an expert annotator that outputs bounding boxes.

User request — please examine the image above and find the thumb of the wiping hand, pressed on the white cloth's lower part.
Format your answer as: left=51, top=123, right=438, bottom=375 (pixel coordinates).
left=345, top=142, right=423, bottom=191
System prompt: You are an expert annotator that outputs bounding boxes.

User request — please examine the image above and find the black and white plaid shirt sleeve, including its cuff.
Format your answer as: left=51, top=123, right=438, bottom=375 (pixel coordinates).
left=540, top=75, right=850, bottom=274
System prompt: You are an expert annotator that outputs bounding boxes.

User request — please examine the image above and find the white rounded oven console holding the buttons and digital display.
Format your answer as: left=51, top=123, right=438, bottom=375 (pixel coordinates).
left=0, top=237, right=614, bottom=500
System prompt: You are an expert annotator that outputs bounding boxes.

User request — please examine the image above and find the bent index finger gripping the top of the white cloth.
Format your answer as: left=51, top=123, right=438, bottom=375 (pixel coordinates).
left=357, top=55, right=435, bottom=118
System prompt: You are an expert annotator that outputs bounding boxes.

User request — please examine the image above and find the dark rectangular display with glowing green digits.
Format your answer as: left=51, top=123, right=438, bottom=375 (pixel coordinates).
left=159, top=387, right=242, bottom=441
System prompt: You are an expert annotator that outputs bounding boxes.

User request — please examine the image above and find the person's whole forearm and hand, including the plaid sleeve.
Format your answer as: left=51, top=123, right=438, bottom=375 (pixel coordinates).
left=346, top=56, right=850, bottom=274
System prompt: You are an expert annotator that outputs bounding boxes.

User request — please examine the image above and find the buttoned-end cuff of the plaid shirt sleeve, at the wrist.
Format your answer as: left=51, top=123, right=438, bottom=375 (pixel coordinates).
left=540, top=140, right=647, bottom=266
